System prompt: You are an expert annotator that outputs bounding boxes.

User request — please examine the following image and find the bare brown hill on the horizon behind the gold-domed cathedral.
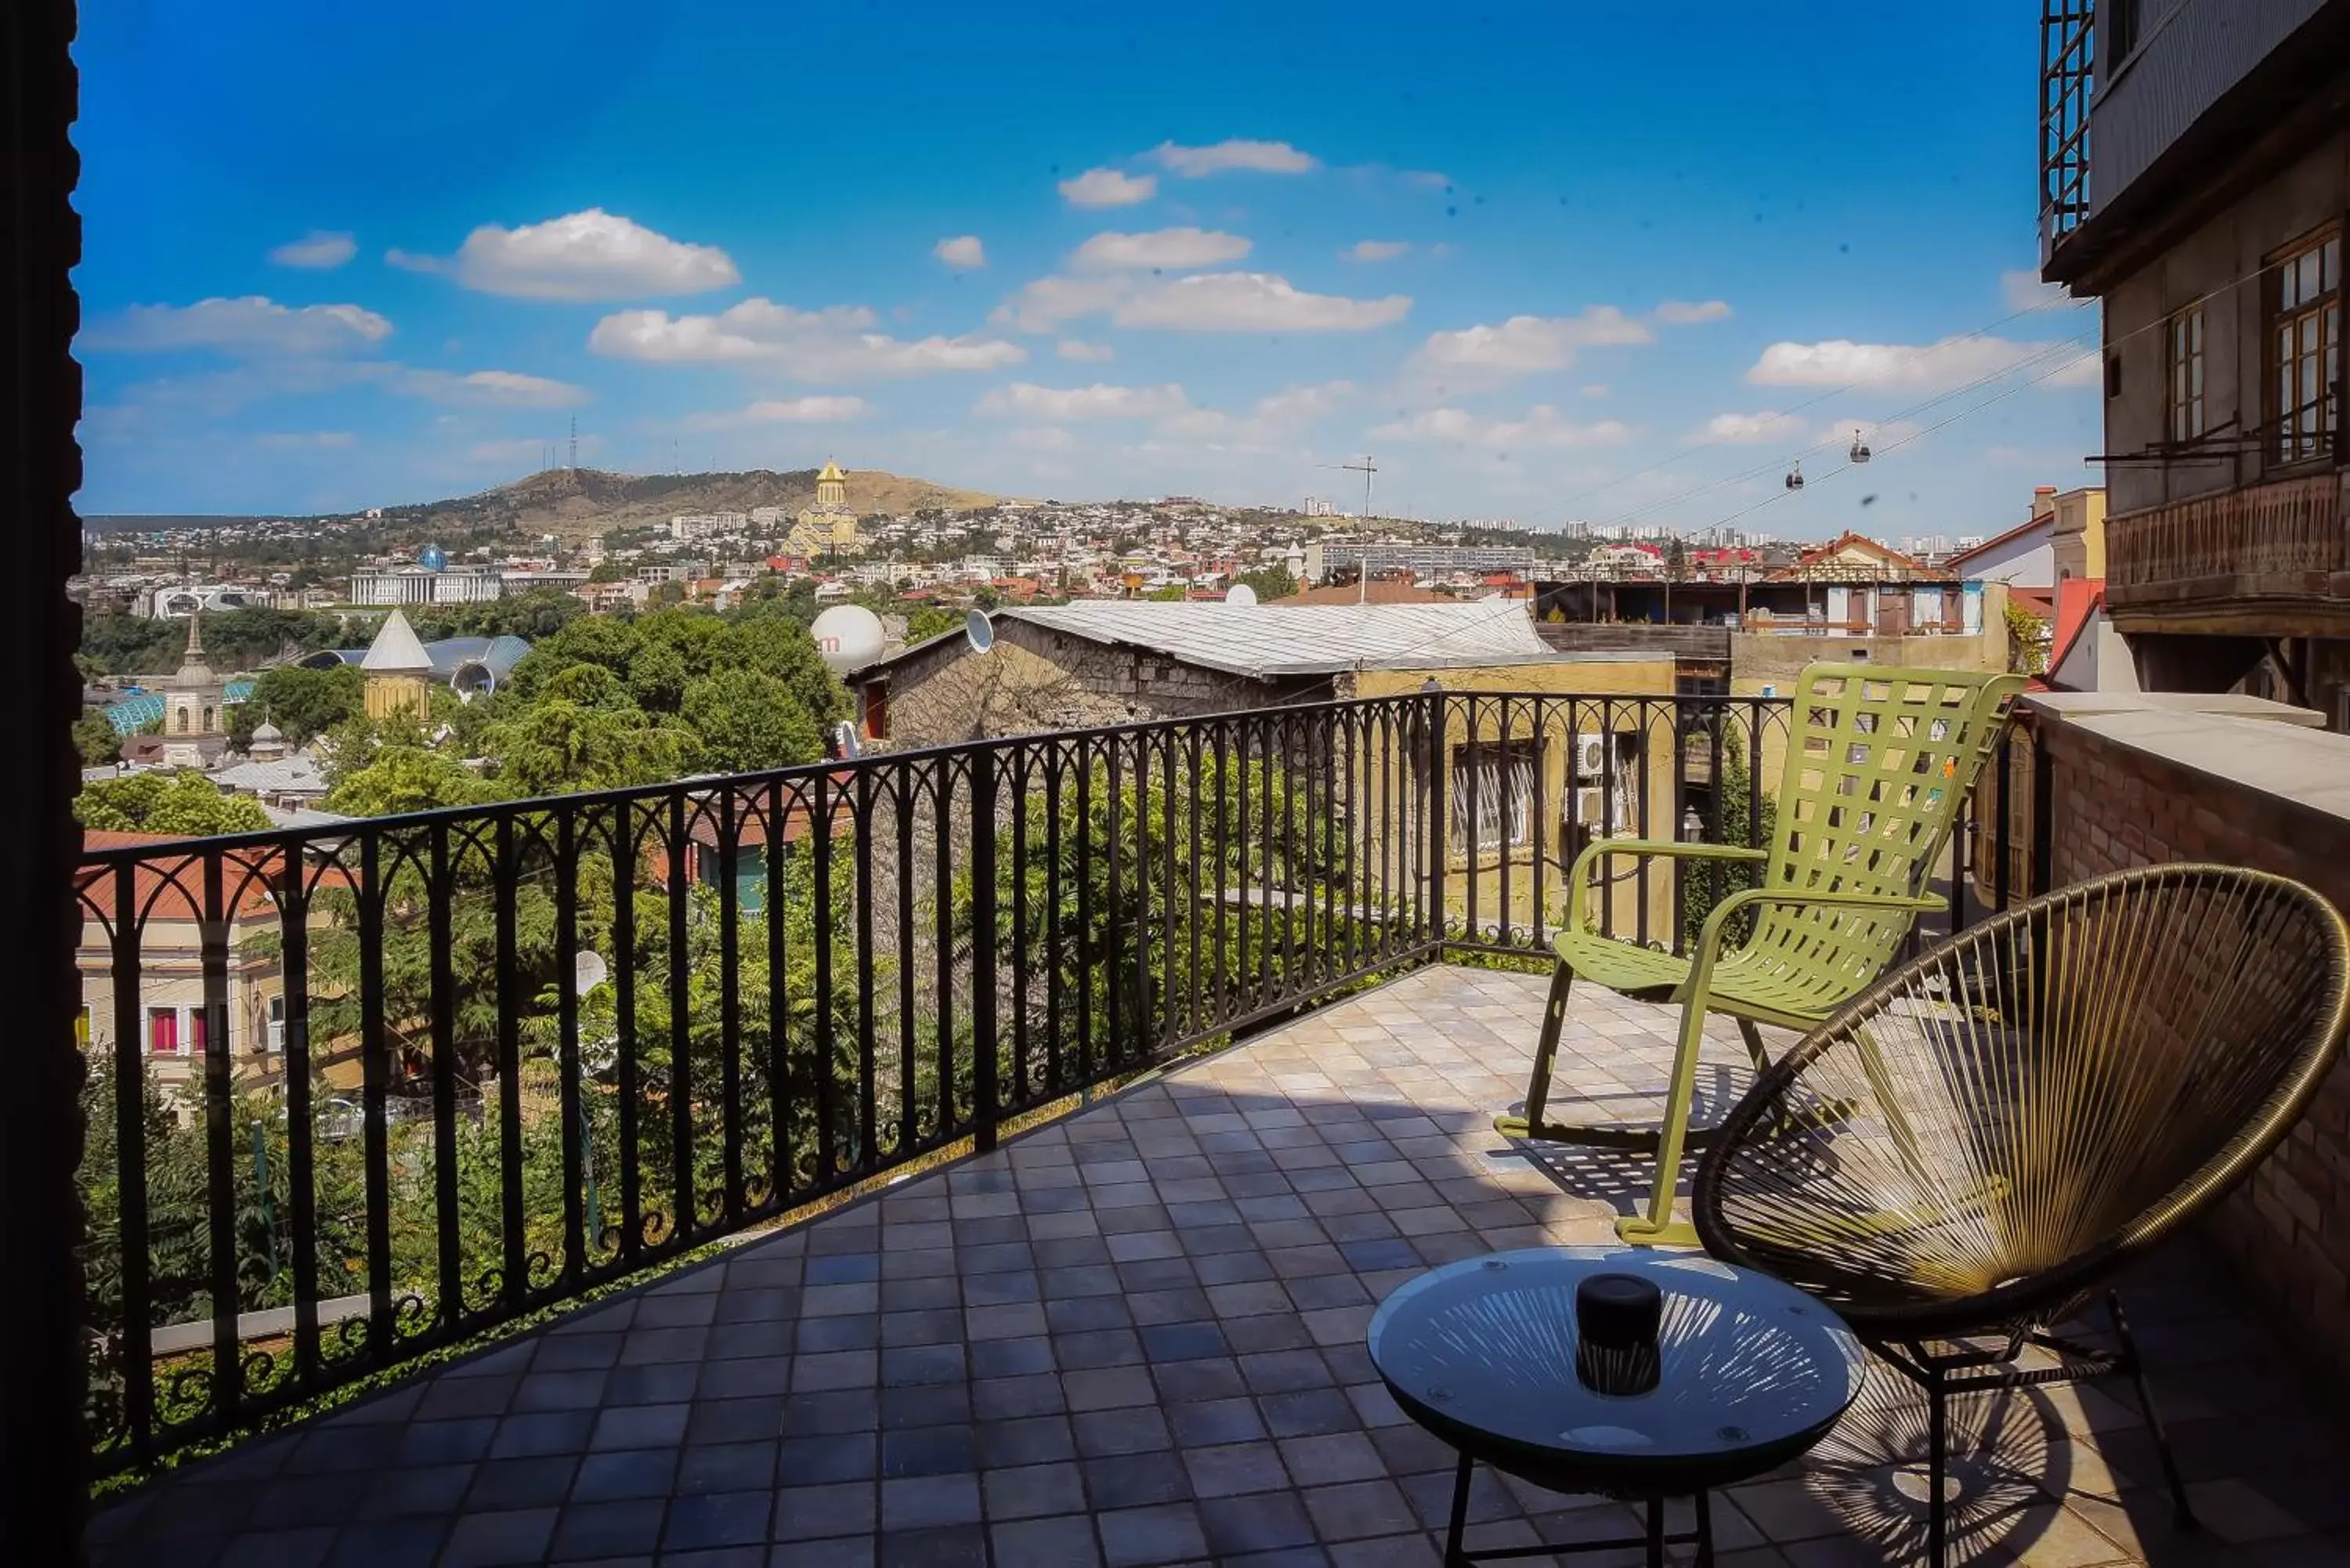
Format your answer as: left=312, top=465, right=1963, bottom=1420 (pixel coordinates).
left=383, top=468, right=996, bottom=540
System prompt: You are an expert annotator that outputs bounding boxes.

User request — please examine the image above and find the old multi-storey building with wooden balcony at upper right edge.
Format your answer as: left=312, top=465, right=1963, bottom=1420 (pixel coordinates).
left=2040, top=0, right=2350, bottom=728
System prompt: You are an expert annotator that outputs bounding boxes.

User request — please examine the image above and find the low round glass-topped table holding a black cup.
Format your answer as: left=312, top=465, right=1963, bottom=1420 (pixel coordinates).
left=1370, top=1246, right=1864, bottom=1563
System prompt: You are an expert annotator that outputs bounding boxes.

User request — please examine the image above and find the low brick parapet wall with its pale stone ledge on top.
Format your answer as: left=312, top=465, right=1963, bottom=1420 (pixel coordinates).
left=2016, top=695, right=2350, bottom=1389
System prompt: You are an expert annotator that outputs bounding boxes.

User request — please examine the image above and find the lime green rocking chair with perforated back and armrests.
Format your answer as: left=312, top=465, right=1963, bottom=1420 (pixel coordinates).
left=1495, top=663, right=2023, bottom=1246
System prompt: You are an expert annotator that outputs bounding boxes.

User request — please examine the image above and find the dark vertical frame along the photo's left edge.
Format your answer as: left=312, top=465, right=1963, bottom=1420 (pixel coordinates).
left=0, top=0, right=87, bottom=1568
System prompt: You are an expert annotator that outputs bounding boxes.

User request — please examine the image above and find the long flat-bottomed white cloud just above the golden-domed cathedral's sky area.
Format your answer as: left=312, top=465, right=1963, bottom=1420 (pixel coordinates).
left=588, top=298, right=1027, bottom=381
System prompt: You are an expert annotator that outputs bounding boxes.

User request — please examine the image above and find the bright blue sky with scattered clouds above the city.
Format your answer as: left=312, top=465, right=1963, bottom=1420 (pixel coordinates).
left=78, top=0, right=2099, bottom=538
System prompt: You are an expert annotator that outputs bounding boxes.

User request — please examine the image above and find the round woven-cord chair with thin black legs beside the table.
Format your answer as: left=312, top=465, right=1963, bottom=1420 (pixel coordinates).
left=1694, top=865, right=2350, bottom=1563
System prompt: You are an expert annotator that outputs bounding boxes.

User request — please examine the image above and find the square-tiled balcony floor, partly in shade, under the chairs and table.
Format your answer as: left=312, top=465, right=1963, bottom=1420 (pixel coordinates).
left=89, top=969, right=2350, bottom=1568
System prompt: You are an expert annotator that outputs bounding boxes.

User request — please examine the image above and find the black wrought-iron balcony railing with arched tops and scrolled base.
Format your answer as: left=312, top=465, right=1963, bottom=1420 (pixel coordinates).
left=80, top=693, right=2005, bottom=1469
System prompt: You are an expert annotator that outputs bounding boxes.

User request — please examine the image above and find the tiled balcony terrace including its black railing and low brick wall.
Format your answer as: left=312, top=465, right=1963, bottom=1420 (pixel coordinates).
left=64, top=691, right=2350, bottom=1568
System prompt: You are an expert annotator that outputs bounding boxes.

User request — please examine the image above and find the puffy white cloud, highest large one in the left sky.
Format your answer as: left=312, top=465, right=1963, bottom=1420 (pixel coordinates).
left=385, top=207, right=743, bottom=301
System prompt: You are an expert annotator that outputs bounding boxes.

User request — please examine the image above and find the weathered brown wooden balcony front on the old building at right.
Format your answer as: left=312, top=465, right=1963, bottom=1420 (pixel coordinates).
left=2106, top=470, right=2350, bottom=637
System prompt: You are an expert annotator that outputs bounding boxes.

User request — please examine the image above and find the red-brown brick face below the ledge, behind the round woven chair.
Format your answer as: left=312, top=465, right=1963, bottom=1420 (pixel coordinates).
left=2019, top=721, right=2350, bottom=1389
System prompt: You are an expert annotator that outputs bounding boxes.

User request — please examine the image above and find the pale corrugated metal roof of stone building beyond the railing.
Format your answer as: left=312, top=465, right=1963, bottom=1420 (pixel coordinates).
left=996, top=599, right=1551, bottom=677
